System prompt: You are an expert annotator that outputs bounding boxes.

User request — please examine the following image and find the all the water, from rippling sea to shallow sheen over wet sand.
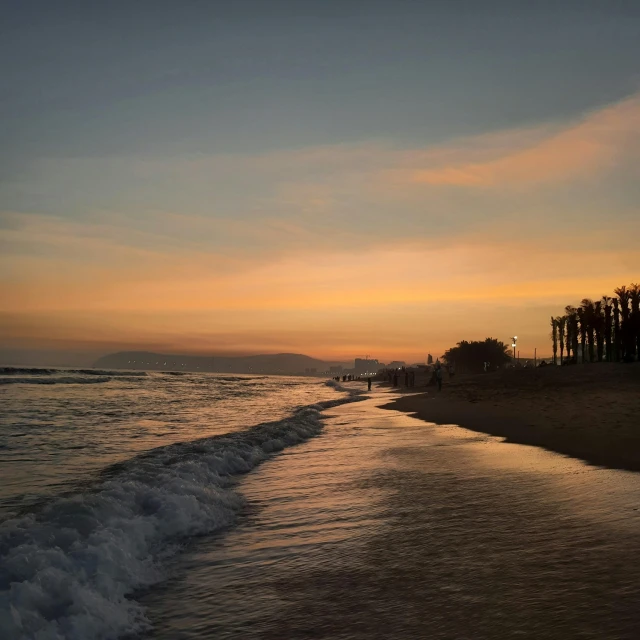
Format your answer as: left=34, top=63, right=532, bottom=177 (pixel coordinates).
left=0, top=368, right=640, bottom=640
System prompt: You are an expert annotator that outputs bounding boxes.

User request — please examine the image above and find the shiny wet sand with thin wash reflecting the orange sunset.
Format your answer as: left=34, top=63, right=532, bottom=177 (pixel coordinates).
left=146, top=399, right=640, bottom=639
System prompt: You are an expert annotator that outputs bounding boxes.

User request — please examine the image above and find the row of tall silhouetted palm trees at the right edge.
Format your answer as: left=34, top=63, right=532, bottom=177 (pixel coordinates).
left=551, top=283, right=640, bottom=364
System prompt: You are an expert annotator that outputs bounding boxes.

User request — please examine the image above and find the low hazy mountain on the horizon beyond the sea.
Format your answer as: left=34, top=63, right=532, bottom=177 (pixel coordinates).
left=93, top=351, right=353, bottom=375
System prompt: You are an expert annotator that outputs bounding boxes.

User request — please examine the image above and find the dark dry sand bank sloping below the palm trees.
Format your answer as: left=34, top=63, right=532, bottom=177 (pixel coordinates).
left=383, top=363, right=640, bottom=471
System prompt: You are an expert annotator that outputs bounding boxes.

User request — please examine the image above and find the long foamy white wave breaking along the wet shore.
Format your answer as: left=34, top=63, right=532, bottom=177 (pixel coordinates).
left=0, top=393, right=363, bottom=640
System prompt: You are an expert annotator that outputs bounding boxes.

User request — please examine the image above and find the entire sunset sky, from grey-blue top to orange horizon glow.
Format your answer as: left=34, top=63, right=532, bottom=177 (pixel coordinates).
left=0, top=0, right=640, bottom=362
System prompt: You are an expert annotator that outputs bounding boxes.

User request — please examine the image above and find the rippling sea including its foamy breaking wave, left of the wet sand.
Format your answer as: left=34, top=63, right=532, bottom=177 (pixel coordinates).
left=0, top=367, right=359, bottom=639
